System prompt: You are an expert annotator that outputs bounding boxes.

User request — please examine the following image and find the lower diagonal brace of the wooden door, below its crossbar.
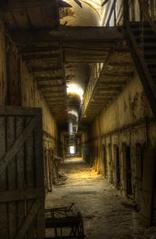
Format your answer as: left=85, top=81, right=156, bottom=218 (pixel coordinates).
left=15, top=199, right=41, bottom=239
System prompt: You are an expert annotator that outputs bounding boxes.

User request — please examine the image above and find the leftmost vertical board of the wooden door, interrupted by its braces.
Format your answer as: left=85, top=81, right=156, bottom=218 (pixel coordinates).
left=0, top=117, right=9, bottom=239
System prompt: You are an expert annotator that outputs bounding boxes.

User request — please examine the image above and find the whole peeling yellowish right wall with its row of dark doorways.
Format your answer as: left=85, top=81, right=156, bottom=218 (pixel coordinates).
left=90, top=74, right=156, bottom=224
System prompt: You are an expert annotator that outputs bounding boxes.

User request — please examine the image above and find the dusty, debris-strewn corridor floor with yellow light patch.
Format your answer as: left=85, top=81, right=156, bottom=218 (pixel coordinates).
left=46, top=159, right=144, bottom=239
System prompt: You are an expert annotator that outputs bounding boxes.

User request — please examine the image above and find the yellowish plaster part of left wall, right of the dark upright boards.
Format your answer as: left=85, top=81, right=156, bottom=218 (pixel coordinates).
left=21, top=62, right=57, bottom=191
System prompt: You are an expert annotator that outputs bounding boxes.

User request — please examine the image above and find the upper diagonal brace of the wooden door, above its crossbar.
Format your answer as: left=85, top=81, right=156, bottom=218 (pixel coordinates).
left=0, top=118, right=36, bottom=174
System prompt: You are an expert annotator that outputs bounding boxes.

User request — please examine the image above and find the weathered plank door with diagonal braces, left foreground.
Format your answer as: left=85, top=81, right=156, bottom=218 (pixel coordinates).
left=0, top=107, right=45, bottom=239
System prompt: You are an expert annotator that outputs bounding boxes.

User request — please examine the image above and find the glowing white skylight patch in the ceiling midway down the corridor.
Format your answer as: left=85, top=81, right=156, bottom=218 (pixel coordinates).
left=67, top=83, right=84, bottom=101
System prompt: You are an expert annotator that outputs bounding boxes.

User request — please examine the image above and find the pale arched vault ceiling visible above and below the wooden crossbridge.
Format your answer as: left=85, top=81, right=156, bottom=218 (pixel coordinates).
left=59, top=0, right=102, bottom=116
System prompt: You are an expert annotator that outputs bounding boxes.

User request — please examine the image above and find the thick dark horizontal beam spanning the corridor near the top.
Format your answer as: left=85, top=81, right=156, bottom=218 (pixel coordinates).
left=11, top=27, right=123, bottom=46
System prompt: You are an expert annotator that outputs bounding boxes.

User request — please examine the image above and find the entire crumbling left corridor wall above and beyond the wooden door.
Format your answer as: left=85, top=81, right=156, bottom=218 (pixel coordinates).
left=0, top=22, right=58, bottom=191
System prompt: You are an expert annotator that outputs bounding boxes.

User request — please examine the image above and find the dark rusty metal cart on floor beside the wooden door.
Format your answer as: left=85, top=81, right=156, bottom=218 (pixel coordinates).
left=45, top=204, right=85, bottom=239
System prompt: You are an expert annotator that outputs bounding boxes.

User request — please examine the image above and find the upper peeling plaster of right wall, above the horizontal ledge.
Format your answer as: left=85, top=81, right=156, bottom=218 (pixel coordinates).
left=93, top=75, right=152, bottom=136
